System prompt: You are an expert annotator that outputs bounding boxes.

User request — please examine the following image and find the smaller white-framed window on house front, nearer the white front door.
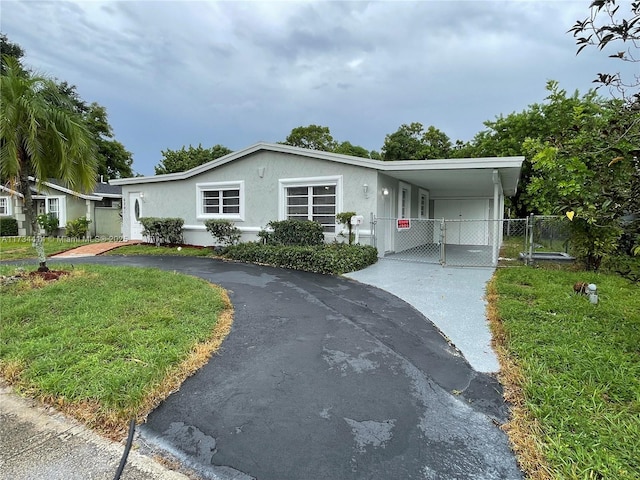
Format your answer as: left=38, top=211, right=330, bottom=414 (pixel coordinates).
left=196, top=181, right=244, bottom=220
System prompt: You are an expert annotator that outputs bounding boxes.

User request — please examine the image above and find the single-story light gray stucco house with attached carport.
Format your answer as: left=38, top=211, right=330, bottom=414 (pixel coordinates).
left=111, top=143, right=524, bottom=263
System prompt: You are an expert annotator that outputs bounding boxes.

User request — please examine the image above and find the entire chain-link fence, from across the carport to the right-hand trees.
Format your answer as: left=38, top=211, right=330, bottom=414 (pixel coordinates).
left=371, top=216, right=568, bottom=267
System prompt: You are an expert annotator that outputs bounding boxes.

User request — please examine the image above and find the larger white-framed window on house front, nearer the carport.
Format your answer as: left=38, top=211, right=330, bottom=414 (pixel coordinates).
left=280, top=177, right=341, bottom=233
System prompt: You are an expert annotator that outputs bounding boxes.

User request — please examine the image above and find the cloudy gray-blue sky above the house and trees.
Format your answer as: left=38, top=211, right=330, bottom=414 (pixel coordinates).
left=0, top=0, right=630, bottom=175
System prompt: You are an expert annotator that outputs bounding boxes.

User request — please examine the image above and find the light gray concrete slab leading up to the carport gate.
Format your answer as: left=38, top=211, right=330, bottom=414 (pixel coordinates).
left=345, top=258, right=500, bottom=373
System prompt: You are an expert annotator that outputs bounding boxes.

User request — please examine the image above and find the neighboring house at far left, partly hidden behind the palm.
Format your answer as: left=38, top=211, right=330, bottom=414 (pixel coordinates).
left=0, top=177, right=122, bottom=237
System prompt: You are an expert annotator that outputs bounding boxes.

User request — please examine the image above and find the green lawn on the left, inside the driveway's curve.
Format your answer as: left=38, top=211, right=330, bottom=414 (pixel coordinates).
left=0, top=265, right=230, bottom=436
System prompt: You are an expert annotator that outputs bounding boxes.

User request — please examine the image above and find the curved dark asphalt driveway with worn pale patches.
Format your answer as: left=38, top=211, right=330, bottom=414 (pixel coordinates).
left=50, top=256, right=522, bottom=480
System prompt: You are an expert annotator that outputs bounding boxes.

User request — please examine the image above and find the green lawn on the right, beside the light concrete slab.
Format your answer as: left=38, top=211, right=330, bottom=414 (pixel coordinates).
left=495, top=268, right=640, bottom=479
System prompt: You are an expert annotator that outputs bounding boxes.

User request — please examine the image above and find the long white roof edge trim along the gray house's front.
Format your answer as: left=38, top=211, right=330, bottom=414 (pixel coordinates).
left=109, top=142, right=524, bottom=185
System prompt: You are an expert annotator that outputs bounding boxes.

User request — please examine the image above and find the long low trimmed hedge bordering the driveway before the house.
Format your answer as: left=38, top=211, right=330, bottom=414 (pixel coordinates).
left=224, top=242, right=378, bottom=275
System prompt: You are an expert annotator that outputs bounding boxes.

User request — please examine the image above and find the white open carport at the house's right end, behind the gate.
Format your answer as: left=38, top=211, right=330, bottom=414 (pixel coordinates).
left=371, top=157, right=524, bottom=266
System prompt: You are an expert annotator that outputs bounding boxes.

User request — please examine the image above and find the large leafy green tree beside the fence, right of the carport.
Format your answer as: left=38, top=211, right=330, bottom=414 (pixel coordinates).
left=523, top=86, right=640, bottom=270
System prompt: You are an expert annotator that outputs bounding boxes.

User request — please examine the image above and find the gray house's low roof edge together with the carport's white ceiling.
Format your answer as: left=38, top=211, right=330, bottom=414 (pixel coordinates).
left=110, top=142, right=524, bottom=197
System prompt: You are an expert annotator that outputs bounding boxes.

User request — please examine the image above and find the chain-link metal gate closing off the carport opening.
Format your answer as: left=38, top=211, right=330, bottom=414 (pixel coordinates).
left=371, top=216, right=527, bottom=267
